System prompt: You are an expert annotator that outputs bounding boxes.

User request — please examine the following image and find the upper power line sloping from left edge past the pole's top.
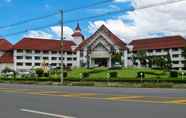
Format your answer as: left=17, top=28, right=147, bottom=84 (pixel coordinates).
left=0, top=0, right=112, bottom=29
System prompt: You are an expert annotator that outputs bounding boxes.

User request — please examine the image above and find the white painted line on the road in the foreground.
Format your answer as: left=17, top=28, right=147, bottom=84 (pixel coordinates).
left=20, top=109, right=75, bottom=118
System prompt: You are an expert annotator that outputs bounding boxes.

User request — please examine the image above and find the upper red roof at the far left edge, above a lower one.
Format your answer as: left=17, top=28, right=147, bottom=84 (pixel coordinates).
left=0, top=39, right=12, bottom=51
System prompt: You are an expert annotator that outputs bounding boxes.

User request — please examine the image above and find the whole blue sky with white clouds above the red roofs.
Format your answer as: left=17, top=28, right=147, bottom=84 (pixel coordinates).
left=0, top=0, right=186, bottom=43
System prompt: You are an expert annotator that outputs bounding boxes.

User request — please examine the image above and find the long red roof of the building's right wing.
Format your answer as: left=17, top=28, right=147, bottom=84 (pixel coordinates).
left=130, top=36, right=186, bottom=51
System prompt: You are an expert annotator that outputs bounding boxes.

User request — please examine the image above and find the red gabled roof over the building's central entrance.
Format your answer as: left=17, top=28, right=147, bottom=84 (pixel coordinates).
left=76, top=25, right=127, bottom=50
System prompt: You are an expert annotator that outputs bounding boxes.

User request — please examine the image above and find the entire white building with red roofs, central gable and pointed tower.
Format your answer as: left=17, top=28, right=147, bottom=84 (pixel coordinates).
left=0, top=24, right=186, bottom=72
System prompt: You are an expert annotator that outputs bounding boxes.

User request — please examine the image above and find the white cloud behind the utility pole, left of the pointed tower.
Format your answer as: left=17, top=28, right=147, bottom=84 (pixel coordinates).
left=24, top=26, right=73, bottom=40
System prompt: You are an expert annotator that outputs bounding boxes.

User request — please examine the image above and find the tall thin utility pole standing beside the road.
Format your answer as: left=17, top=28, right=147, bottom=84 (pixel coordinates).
left=60, top=10, right=64, bottom=84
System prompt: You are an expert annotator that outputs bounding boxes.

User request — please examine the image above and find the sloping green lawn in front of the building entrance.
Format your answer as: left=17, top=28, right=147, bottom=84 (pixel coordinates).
left=68, top=68, right=174, bottom=79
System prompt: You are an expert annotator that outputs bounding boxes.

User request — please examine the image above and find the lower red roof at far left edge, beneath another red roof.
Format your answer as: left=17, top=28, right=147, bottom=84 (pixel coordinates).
left=0, top=51, right=13, bottom=63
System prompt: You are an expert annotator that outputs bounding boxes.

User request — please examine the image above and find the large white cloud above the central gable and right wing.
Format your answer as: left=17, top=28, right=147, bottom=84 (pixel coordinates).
left=88, top=0, right=186, bottom=42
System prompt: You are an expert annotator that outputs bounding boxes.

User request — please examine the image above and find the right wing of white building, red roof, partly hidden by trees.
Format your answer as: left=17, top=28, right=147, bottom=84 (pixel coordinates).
left=128, top=36, right=186, bottom=70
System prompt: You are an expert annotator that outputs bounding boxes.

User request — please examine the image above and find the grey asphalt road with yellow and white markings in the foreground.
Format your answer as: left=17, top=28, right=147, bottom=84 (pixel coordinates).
left=0, top=84, right=186, bottom=118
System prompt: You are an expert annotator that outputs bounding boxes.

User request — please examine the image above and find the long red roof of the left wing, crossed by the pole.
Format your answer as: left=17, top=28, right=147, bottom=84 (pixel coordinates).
left=14, top=38, right=75, bottom=51
